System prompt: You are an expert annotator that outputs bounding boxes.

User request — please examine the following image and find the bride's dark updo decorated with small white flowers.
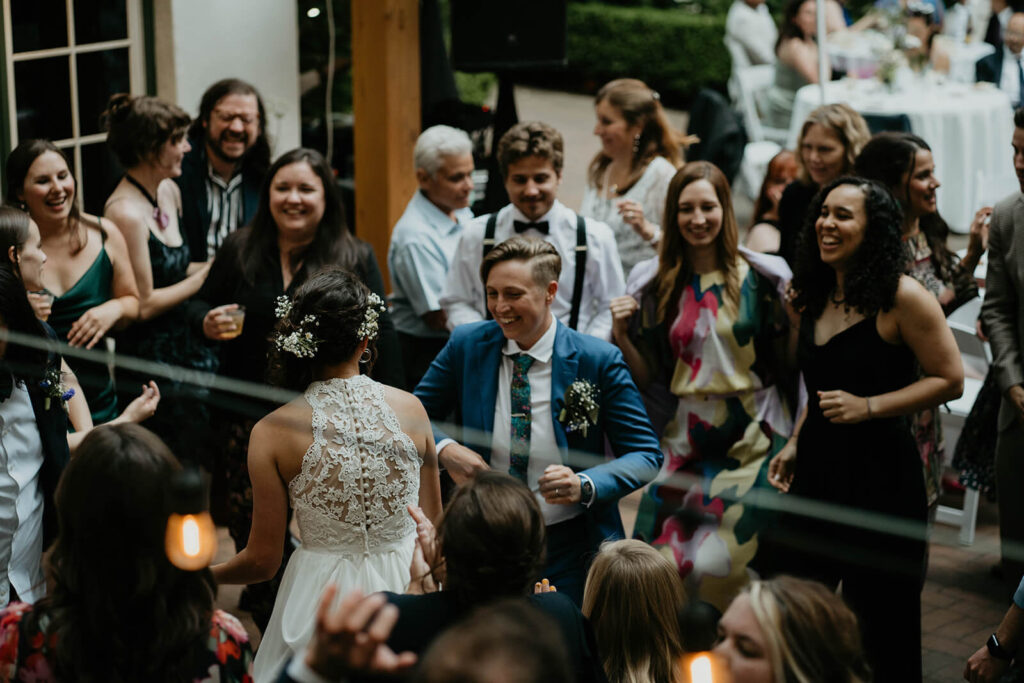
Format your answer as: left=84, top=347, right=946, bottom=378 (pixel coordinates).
left=267, top=266, right=379, bottom=391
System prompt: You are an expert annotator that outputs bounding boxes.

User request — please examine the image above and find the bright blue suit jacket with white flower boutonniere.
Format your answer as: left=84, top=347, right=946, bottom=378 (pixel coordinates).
left=415, top=321, right=663, bottom=546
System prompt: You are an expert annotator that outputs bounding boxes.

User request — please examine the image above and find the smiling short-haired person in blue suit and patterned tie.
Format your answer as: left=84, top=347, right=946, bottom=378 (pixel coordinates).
left=415, top=237, right=663, bottom=604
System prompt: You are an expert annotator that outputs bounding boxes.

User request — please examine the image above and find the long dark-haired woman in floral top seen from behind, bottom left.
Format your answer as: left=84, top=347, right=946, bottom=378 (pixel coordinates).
left=0, top=424, right=252, bottom=683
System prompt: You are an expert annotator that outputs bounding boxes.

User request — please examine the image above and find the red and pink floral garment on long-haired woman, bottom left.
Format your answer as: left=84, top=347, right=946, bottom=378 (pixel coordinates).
left=0, top=602, right=253, bottom=683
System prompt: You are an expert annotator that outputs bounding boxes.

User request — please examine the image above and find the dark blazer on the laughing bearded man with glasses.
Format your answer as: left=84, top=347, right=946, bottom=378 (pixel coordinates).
left=174, top=139, right=263, bottom=261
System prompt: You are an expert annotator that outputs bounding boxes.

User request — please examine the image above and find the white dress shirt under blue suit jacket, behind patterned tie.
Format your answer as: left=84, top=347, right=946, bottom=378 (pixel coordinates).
left=490, top=318, right=583, bottom=525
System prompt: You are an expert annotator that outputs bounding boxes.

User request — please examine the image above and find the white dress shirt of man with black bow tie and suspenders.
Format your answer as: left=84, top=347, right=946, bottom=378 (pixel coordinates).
left=440, top=200, right=626, bottom=340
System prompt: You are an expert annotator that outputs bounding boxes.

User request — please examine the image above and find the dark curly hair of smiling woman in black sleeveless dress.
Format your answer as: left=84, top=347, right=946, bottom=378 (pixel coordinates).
left=793, top=176, right=906, bottom=319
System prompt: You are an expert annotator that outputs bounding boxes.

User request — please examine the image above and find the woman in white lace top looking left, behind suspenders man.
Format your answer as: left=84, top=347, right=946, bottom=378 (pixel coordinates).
left=580, top=78, right=688, bottom=275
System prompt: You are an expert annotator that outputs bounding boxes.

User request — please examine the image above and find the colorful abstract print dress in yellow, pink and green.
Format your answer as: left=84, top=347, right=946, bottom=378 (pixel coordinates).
left=635, top=258, right=793, bottom=610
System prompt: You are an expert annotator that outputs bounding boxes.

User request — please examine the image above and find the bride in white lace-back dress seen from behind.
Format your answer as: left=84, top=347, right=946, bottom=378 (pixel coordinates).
left=213, top=268, right=441, bottom=683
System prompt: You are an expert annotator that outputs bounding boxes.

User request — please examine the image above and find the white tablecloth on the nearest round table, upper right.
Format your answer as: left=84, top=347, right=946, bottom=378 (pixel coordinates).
left=786, top=74, right=1016, bottom=232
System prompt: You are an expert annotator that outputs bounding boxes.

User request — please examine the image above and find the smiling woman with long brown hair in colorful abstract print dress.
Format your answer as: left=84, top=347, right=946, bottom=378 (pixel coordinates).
left=611, top=162, right=792, bottom=609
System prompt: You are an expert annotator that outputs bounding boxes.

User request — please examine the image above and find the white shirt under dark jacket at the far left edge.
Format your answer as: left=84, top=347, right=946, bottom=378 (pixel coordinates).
left=0, top=382, right=46, bottom=605
